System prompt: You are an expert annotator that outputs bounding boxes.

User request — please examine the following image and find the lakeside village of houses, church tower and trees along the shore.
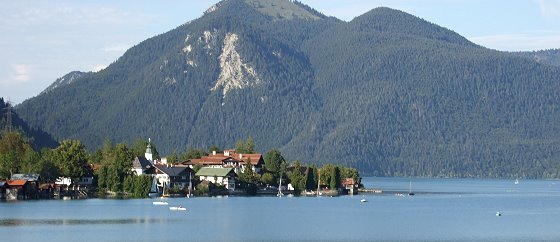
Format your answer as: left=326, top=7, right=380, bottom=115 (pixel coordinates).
left=0, top=140, right=361, bottom=201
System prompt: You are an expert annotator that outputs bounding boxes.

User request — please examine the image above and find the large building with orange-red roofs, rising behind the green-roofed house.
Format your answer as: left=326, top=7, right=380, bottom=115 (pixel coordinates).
left=183, top=150, right=264, bottom=174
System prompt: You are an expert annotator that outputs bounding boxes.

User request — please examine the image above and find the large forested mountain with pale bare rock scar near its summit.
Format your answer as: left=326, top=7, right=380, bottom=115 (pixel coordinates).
left=17, top=0, right=560, bottom=178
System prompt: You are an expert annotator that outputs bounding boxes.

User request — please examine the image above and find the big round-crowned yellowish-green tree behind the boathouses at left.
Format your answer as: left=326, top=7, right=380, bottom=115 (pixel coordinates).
left=53, top=140, right=88, bottom=178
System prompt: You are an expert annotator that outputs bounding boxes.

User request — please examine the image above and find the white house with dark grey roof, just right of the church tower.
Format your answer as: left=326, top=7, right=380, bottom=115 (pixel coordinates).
left=154, top=164, right=194, bottom=193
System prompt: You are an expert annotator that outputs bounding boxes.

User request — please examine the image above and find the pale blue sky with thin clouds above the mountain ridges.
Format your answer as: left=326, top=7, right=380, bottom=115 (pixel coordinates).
left=0, top=0, right=560, bottom=104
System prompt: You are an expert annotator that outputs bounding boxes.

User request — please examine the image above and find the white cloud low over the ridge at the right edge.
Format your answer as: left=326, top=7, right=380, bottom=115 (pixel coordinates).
left=469, top=33, right=560, bottom=51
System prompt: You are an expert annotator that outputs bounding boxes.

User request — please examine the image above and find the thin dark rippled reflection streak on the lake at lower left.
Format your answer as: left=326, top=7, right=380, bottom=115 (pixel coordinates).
left=0, top=218, right=176, bottom=227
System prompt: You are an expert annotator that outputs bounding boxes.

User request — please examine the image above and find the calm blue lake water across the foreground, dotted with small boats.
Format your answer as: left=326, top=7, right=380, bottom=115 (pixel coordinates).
left=0, top=178, right=560, bottom=241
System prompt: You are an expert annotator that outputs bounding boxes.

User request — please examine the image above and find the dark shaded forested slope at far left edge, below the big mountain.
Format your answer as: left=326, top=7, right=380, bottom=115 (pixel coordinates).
left=0, top=98, right=58, bottom=150
